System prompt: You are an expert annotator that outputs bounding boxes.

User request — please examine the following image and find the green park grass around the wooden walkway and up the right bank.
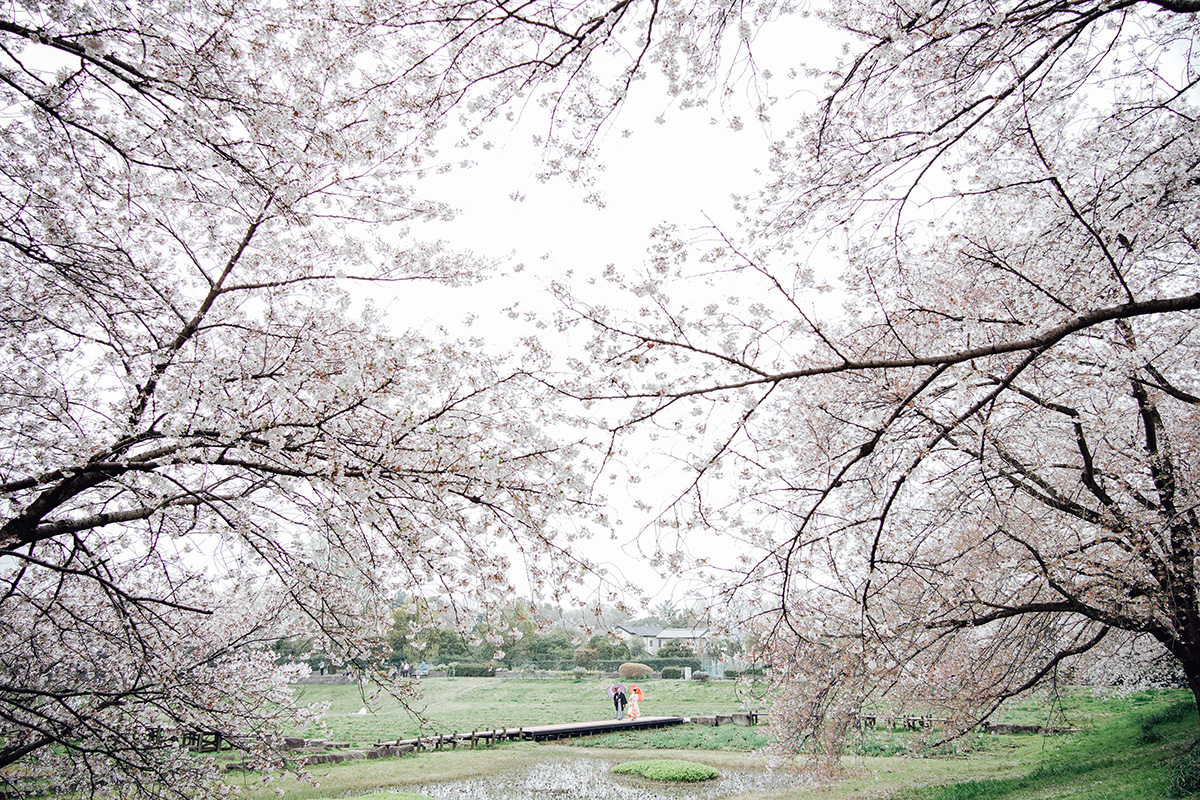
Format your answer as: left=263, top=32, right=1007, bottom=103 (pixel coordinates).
left=226, top=678, right=1200, bottom=800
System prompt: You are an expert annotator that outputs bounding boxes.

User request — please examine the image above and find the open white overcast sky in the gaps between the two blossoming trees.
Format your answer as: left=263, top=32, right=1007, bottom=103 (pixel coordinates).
left=388, top=23, right=829, bottom=603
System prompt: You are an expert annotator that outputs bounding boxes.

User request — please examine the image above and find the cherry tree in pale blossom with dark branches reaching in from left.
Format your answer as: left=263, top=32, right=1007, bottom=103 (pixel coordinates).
left=0, top=0, right=657, bottom=798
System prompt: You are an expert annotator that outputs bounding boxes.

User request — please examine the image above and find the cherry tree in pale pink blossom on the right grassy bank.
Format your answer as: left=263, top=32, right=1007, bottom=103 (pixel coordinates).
left=549, top=0, right=1200, bottom=754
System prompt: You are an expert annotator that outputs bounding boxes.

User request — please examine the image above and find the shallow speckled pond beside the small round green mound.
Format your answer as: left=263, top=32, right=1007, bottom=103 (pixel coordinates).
left=406, top=758, right=803, bottom=800
